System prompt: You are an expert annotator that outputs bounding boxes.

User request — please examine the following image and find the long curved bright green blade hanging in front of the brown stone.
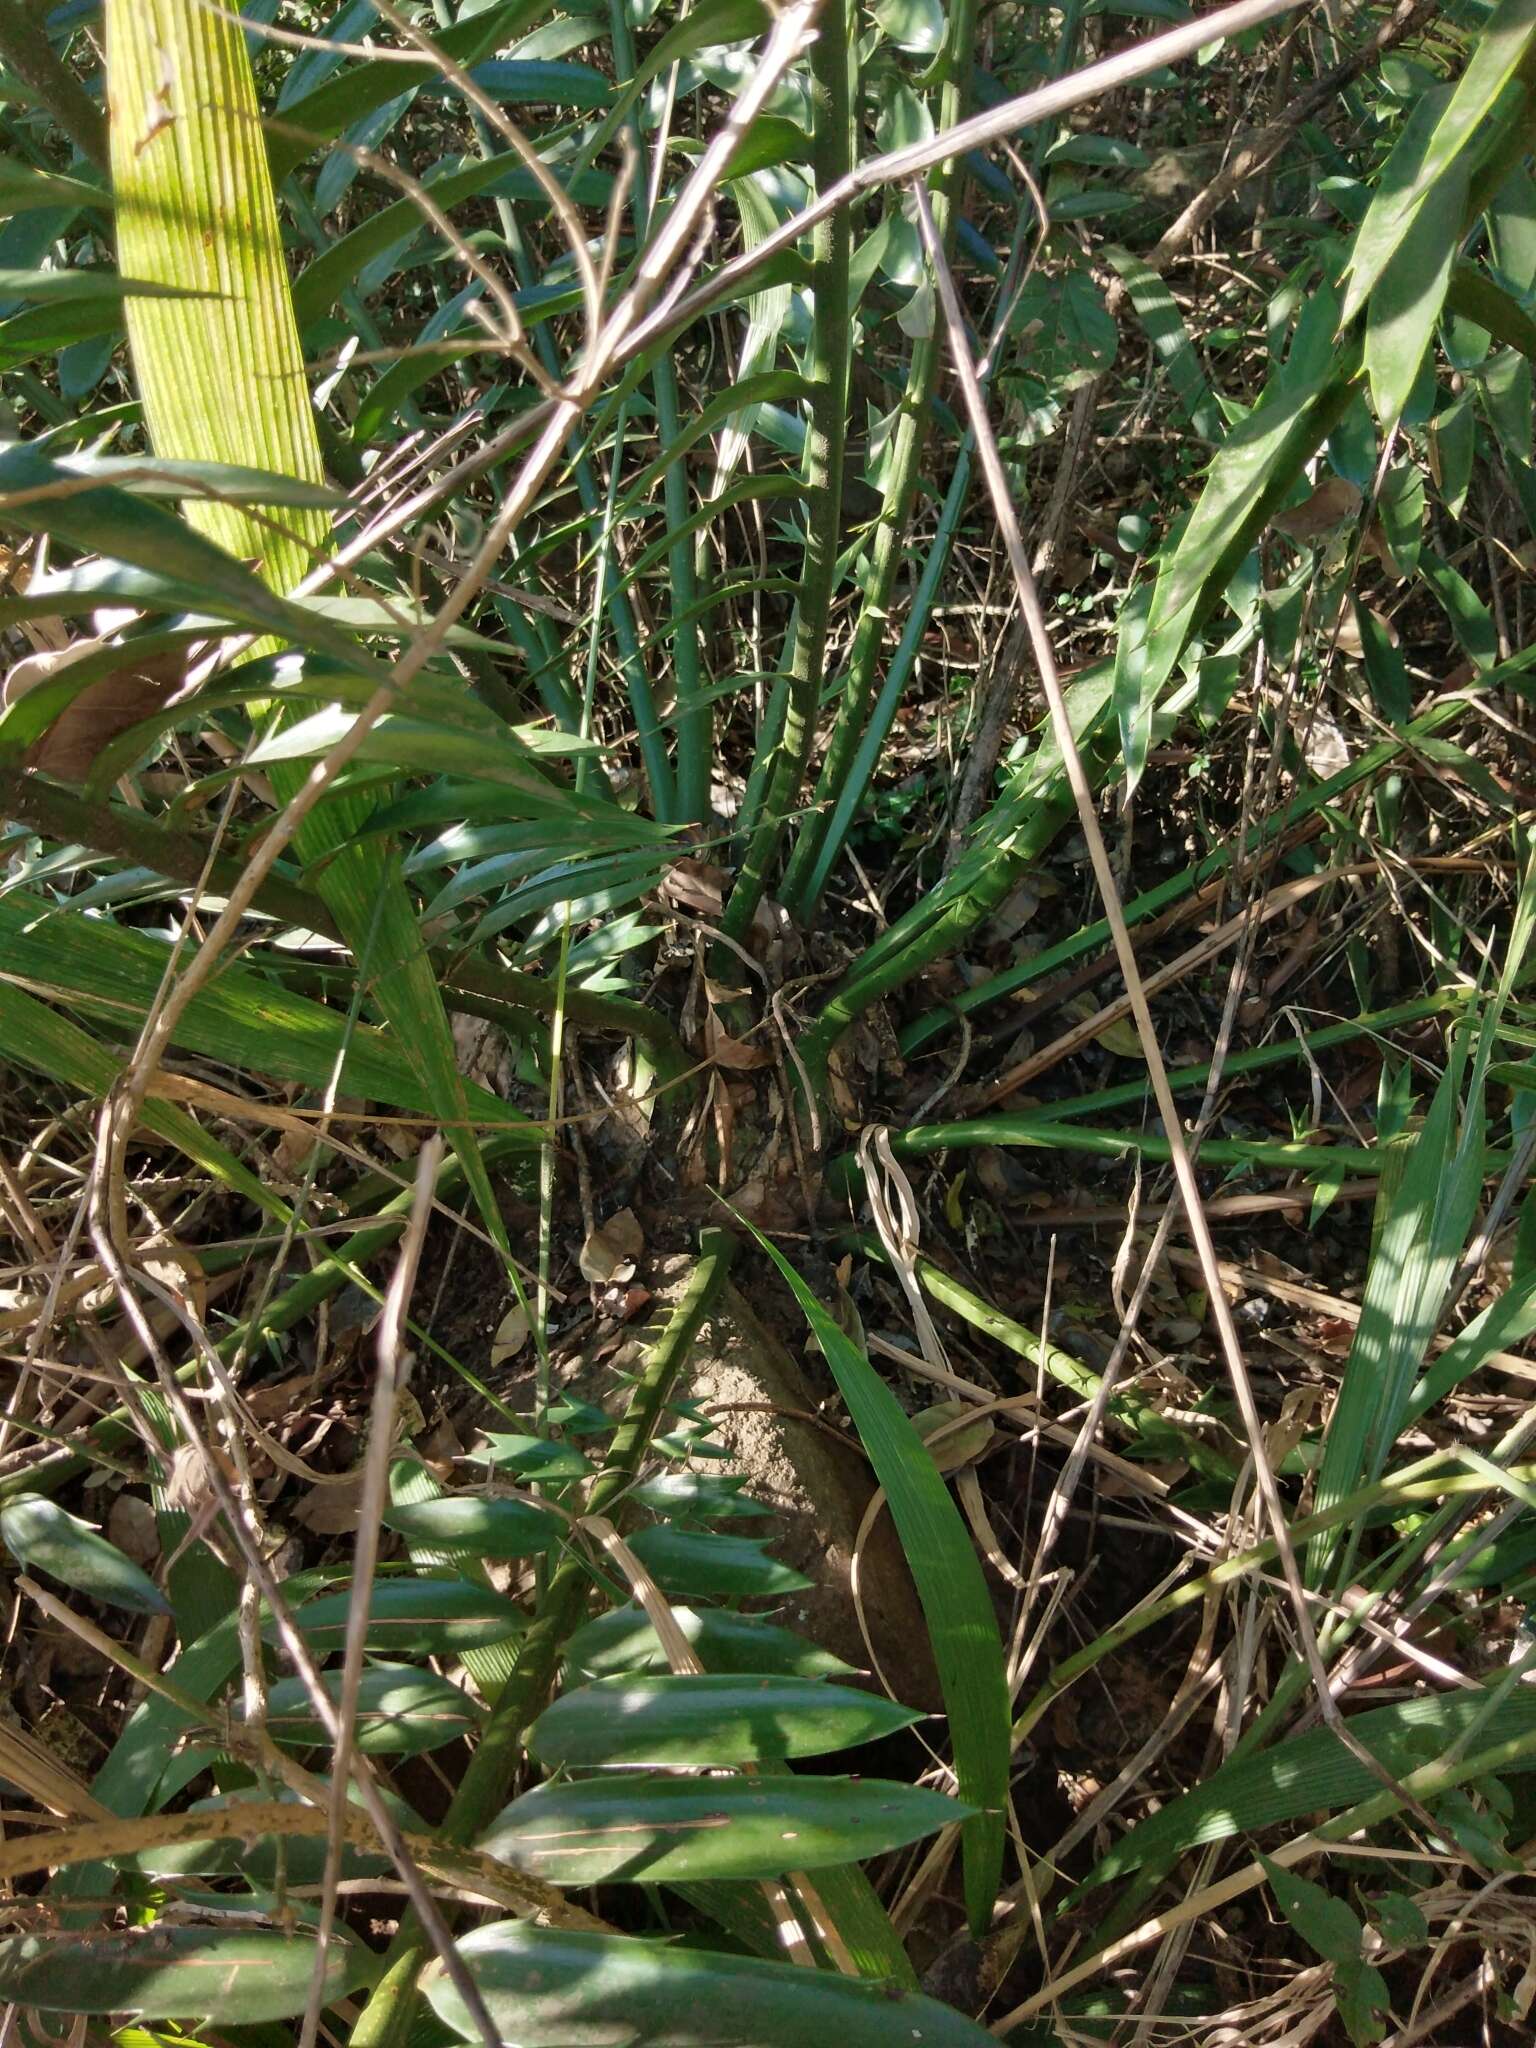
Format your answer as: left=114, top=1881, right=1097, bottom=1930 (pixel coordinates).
left=758, top=1237, right=1012, bottom=1931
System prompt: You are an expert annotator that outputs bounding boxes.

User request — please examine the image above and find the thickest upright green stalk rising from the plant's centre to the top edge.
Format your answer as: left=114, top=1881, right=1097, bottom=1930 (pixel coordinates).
left=721, top=0, right=852, bottom=942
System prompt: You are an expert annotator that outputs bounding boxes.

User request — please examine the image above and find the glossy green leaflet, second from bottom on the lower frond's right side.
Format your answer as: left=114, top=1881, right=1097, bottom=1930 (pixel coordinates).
left=475, top=1776, right=969, bottom=1884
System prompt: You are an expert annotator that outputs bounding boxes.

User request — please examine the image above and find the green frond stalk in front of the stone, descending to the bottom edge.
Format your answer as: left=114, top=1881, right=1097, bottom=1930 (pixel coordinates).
left=352, top=1231, right=737, bottom=2048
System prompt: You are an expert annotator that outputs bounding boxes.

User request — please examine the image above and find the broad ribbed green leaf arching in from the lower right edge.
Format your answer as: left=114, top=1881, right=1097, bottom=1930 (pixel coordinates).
left=1081, top=1686, right=1536, bottom=1892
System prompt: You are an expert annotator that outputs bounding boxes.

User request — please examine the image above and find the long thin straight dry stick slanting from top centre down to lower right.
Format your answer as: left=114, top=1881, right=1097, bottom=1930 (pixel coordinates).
left=911, top=182, right=1427, bottom=1884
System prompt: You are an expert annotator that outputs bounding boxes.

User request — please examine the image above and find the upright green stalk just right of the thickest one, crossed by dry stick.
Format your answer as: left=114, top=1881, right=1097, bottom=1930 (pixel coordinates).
left=782, top=0, right=977, bottom=924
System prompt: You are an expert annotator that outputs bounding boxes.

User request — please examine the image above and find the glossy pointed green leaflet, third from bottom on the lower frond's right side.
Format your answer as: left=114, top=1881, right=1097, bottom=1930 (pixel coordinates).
left=528, top=1673, right=922, bottom=1769
